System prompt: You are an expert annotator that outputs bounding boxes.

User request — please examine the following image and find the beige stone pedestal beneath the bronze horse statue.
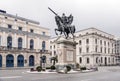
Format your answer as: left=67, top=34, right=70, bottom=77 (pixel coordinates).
left=56, top=40, right=77, bottom=72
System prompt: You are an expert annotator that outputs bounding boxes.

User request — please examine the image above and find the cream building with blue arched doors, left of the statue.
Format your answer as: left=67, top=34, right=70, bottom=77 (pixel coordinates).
left=0, top=11, right=50, bottom=68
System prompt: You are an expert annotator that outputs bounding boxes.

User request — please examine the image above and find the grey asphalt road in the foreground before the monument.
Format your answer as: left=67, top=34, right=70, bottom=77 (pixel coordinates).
left=0, top=66, right=120, bottom=81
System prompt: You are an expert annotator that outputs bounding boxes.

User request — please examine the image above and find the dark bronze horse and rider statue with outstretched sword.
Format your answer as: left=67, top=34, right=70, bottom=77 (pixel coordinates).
left=48, top=7, right=75, bottom=39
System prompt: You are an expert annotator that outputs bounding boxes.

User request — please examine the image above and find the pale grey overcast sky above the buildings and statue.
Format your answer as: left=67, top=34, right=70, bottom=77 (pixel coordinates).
left=0, top=0, right=120, bottom=36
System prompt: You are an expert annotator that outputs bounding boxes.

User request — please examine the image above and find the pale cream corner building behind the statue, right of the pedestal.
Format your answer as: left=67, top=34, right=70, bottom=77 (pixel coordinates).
left=50, top=27, right=116, bottom=66
